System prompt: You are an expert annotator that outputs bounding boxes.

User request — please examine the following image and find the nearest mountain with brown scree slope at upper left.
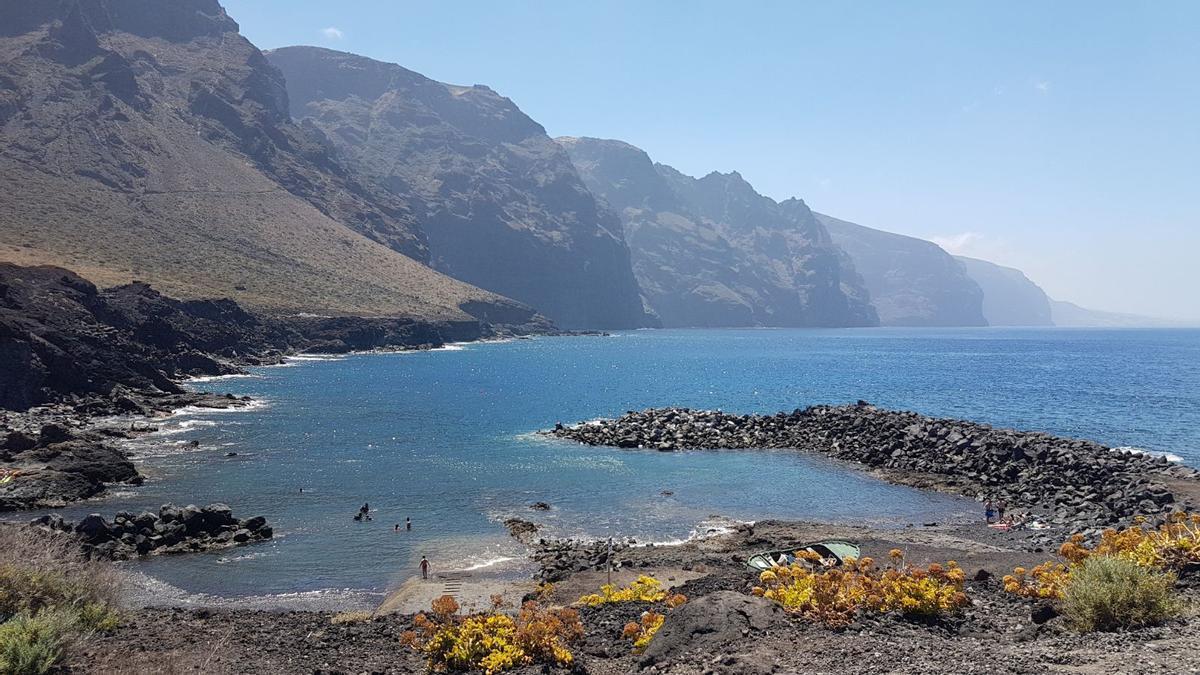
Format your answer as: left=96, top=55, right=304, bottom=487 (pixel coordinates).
left=0, top=0, right=530, bottom=319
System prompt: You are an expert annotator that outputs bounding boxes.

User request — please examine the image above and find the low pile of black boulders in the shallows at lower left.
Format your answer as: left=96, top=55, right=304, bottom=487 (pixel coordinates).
left=30, top=503, right=274, bottom=560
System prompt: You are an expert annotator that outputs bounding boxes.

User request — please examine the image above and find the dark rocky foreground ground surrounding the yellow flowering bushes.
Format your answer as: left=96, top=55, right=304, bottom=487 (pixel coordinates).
left=68, top=521, right=1200, bottom=675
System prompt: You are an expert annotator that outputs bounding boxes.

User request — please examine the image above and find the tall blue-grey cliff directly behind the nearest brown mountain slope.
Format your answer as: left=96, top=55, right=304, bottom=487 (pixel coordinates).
left=268, top=47, right=649, bottom=328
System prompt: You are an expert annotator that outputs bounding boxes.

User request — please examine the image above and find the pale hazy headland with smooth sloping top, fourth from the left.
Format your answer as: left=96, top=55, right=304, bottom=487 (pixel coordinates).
left=816, top=214, right=988, bottom=327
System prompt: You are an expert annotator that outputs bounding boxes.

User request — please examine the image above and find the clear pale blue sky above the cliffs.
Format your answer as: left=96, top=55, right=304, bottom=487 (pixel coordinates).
left=224, top=0, right=1200, bottom=319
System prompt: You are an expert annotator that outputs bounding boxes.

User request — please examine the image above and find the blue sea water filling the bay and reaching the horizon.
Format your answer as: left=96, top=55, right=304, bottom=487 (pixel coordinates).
left=18, top=329, right=1200, bottom=607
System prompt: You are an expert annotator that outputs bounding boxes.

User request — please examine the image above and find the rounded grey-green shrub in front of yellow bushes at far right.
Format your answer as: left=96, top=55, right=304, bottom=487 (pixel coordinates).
left=1062, top=556, right=1178, bottom=632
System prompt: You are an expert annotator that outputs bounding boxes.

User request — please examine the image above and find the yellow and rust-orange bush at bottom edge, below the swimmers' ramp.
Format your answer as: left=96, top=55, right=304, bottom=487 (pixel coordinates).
left=401, top=596, right=583, bottom=675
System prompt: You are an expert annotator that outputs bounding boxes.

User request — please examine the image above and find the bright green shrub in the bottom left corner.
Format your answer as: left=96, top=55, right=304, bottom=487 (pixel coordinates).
left=0, top=609, right=79, bottom=675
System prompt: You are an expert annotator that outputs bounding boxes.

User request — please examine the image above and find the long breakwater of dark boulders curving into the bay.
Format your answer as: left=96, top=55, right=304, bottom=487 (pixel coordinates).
left=546, top=401, right=1200, bottom=531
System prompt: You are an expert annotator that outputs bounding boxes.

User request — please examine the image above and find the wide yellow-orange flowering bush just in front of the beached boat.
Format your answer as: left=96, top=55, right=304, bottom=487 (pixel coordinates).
left=751, top=551, right=968, bottom=626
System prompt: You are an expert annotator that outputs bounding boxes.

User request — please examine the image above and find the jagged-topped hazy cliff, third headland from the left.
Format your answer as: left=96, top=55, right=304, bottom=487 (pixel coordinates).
left=558, top=138, right=877, bottom=327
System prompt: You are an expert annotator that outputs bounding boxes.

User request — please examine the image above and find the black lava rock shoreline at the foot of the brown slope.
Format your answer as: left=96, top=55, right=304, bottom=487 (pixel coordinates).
left=0, top=263, right=536, bottom=413
